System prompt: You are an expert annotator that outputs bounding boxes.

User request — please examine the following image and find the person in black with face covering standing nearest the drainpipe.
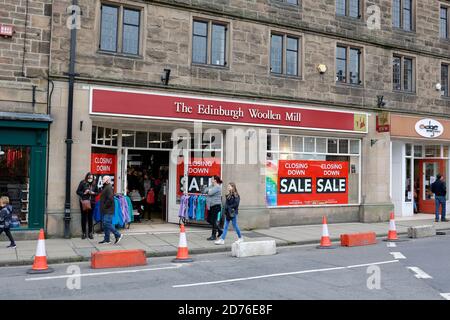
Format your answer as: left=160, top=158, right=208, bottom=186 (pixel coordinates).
left=77, top=172, right=98, bottom=239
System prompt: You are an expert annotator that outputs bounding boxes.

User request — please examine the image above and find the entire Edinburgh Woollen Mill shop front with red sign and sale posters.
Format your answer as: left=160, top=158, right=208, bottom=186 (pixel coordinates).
left=85, top=87, right=368, bottom=227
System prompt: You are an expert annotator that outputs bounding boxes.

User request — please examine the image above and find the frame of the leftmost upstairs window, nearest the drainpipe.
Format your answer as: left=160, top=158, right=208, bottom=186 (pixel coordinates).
left=98, top=1, right=145, bottom=58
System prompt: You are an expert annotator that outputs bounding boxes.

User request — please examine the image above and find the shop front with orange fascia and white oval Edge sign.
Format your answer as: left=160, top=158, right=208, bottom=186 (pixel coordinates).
left=389, top=114, right=450, bottom=216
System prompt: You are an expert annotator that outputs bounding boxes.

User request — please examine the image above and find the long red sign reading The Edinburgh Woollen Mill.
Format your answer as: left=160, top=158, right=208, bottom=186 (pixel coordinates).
left=91, top=88, right=367, bottom=133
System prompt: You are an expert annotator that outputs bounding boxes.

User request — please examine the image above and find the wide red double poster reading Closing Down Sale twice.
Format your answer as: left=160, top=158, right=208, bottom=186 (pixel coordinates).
left=277, top=160, right=348, bottom=206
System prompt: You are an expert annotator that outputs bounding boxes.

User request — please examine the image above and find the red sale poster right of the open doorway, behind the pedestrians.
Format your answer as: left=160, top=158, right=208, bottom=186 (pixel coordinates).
left=177, top=158, right=221, bottom=196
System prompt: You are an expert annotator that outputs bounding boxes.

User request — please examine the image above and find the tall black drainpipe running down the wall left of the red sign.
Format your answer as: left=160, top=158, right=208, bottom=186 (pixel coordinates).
left=64, top=0, right=78, bottom=239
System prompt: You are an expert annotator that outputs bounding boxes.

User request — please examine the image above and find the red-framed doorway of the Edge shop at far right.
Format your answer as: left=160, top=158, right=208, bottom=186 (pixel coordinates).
left=414, top=159, right=446, bottom=214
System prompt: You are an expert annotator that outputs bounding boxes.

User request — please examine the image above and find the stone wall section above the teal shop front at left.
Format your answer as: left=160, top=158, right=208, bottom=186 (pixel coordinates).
left=0, top=0, right=52, bottom=113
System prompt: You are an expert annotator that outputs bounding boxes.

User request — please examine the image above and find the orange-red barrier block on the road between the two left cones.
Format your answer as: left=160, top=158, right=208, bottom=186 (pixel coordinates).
left=91, top=250, right=147, bottom=269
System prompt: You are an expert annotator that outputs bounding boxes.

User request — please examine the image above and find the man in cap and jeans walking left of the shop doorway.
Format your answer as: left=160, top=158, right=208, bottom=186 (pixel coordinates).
left=99, top=176, right=123, bottom=244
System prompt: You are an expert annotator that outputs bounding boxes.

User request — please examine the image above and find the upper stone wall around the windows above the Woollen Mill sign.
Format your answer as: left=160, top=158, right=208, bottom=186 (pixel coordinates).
left=51, top=0, right=450, bottom=116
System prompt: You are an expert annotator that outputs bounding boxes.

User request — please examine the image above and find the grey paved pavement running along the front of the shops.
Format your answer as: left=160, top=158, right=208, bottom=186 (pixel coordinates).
left=0, top=215, right=450, bottom=267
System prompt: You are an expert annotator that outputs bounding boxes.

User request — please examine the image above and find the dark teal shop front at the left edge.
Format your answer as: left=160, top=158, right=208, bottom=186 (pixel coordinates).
left=0, top=114, right=51, bottom=230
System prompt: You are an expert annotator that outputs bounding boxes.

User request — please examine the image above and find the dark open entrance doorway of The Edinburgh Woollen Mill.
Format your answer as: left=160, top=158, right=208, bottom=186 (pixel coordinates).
left=122, top=149, right=170, bottom=223
